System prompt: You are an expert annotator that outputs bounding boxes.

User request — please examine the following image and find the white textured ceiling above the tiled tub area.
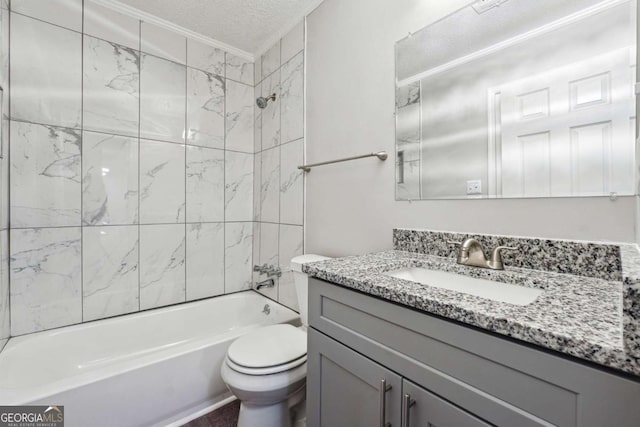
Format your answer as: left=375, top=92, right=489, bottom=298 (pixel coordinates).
left=115, top=0, right=319, bottom=53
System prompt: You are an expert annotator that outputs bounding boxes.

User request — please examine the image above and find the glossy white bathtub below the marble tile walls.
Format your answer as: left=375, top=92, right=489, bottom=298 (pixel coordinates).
left=0, top=291, right=299, bottom=427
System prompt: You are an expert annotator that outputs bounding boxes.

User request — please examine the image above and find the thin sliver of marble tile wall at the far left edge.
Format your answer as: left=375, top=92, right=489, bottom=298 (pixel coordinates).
left=0, top=0, right=11, bottom=350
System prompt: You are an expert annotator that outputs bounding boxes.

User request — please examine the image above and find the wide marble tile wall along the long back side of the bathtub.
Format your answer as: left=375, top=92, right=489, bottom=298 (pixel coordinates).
left=7, top=0, right=256, bottom=338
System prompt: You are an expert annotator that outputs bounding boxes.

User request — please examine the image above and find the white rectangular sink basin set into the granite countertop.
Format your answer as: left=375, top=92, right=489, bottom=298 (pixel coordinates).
left=384, top=267, right=543, bottom=305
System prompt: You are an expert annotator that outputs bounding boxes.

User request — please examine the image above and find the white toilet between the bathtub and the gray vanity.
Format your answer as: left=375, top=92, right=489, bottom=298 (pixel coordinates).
left=221, top=254, right=329, bottom=427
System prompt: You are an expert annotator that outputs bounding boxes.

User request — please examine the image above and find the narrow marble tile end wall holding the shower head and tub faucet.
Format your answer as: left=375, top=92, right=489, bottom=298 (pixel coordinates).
left=253, top=22, right=305, bottom=310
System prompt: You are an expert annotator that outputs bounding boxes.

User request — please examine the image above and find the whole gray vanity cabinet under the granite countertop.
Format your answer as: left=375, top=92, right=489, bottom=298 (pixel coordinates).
left=307, top=279, right=640, bottom=427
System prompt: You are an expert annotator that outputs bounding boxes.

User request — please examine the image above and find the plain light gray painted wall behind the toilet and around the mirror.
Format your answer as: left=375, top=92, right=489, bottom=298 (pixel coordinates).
left=305, top=0, right=636, bottom=256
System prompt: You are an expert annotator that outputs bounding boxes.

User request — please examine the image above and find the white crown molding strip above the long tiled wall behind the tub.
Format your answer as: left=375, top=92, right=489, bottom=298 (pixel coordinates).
left=88, top=0, right=255, bottom=62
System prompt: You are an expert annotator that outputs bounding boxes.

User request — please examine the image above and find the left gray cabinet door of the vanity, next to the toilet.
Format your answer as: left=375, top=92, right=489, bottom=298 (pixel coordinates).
left=307, top=329, right=402, bottom=427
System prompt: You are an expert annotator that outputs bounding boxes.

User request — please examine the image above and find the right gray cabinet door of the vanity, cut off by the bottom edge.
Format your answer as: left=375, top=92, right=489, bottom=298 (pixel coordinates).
left=402, top=379, right=491, bottom=427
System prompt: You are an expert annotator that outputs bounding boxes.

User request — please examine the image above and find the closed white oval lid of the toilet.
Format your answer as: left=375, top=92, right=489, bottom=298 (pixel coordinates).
left=227, top=325, right=307, bottom=369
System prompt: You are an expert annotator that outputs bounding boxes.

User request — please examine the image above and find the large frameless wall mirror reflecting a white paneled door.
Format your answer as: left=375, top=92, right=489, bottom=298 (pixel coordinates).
left=396, top=0, right=637, bottom=200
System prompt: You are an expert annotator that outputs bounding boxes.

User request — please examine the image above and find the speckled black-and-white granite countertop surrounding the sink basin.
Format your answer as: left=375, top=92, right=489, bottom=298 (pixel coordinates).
left=303, top=250, right=640, bottom=375
